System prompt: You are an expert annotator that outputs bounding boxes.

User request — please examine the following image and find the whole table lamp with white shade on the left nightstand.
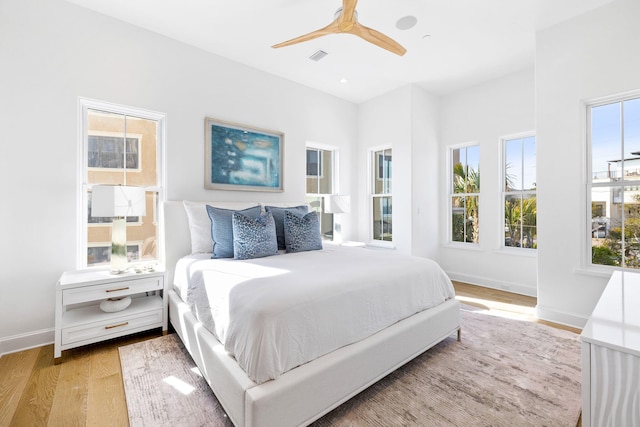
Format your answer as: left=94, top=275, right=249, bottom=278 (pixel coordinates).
left=91, top=185, right=146, bottom=274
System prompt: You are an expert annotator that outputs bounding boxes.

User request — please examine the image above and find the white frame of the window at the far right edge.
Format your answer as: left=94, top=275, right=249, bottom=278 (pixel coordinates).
left=581, top=90, right=640, bottom=275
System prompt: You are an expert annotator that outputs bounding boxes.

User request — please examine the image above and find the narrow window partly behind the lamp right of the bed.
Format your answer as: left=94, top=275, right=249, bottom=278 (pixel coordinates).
left=307, top=147, right=335, bottom=240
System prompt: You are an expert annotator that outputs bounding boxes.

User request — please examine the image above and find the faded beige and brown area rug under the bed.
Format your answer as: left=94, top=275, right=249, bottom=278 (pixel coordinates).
left=120, top=306, right=580, bottom=427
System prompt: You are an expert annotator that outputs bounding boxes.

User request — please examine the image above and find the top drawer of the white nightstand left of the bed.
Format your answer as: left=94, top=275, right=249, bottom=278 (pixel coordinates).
left=62, top=277, right=163, bottom=305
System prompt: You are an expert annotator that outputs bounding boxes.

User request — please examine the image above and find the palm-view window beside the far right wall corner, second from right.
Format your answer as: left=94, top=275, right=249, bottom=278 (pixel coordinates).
left=502, top=135, right=538, bottom=249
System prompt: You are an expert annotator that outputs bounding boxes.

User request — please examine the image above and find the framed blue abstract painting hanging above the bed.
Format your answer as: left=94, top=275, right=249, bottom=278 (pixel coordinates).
left=204, top=117, right=284, bottom=192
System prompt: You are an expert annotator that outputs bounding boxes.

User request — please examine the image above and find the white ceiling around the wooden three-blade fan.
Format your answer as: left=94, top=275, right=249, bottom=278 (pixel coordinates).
left=63, top=0, right=613, bottom=103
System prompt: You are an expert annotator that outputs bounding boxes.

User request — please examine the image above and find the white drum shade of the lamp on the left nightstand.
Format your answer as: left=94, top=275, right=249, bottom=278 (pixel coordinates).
left=91, top=185, right=146, bottom=217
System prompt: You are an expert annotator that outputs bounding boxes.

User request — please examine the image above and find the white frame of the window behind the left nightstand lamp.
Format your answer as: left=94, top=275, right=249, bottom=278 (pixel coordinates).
left=76, top=97, right=166, bottom=268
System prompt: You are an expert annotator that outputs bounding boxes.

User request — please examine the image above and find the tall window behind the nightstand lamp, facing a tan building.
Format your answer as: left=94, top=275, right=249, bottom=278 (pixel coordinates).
left=78, top=99, right=164, bottom=267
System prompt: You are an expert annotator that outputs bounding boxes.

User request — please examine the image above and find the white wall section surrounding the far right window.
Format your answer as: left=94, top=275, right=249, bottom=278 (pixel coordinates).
left=536, top=0, right=640, bottom=327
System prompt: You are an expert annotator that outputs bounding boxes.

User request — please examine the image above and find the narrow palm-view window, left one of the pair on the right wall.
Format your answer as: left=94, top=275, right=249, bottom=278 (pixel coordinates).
left=449, top=145, right=480, bottom=243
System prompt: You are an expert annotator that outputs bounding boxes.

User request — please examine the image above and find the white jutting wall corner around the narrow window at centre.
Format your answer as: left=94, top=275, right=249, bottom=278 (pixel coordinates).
left=357, top=85, right=440, bottom=260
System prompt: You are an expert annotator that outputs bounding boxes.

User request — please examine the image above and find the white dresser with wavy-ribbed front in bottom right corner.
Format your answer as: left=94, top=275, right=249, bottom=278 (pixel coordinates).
left=581, top=271, right=640, bottom=427
